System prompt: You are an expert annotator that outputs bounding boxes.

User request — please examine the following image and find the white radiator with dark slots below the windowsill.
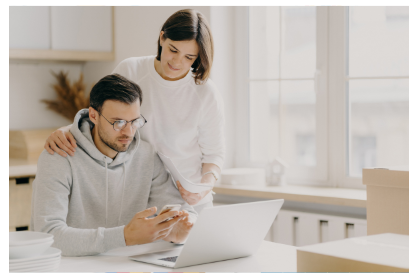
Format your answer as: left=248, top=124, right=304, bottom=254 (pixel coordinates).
left=265, top=210, right=367, bottom=247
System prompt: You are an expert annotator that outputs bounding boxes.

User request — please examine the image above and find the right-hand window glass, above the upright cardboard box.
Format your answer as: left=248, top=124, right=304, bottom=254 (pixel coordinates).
left=346, top=7, right=408, bottom=177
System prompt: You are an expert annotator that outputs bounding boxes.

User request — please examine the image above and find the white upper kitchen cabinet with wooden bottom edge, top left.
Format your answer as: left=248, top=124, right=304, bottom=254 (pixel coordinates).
left=9, top=6, right=114, bottom=61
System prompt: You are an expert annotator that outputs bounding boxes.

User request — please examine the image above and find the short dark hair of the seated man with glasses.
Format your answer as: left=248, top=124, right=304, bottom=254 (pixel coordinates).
left=90, top=74, right=142, bottom=112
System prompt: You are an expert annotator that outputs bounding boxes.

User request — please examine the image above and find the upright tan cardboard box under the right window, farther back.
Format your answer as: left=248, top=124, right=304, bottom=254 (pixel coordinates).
left=363, top=166, right=409, bottom=235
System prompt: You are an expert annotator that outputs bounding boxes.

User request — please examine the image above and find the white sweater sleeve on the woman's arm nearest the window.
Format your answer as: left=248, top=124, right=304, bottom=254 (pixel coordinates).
left=198, top=80, right=225, bottom=169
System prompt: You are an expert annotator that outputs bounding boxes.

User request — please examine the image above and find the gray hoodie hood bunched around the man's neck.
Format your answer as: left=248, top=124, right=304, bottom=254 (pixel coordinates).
left=70, top=109, right=140, bottom=167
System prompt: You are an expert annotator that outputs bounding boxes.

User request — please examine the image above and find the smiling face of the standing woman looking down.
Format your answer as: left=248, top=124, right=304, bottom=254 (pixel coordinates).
left=155, top=31, right=199, bottom=81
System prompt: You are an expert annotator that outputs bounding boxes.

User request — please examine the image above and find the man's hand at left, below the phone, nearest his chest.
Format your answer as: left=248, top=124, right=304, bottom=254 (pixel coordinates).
left=124, top=207, right=182, bottom=246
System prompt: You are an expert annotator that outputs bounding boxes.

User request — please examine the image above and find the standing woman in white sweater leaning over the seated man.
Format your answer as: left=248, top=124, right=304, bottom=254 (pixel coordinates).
left=45, top=9, right=225, bottom=213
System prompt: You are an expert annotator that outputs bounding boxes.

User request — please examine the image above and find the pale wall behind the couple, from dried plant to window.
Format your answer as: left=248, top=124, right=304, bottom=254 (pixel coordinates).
left=9, top=7, right=235, bottom=168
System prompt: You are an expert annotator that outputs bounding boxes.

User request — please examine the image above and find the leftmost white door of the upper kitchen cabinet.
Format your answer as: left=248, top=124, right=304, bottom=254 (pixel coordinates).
left=9, top=7, right=50, bottom=49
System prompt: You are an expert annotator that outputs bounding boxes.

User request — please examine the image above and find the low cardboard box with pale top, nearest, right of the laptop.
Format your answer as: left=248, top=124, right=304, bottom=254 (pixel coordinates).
left=297, top=233, right=409, bottom=272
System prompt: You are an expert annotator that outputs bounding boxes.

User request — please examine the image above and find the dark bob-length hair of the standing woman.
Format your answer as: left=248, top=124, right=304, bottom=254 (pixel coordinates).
left=156, top=9, right=214, bottom=84
